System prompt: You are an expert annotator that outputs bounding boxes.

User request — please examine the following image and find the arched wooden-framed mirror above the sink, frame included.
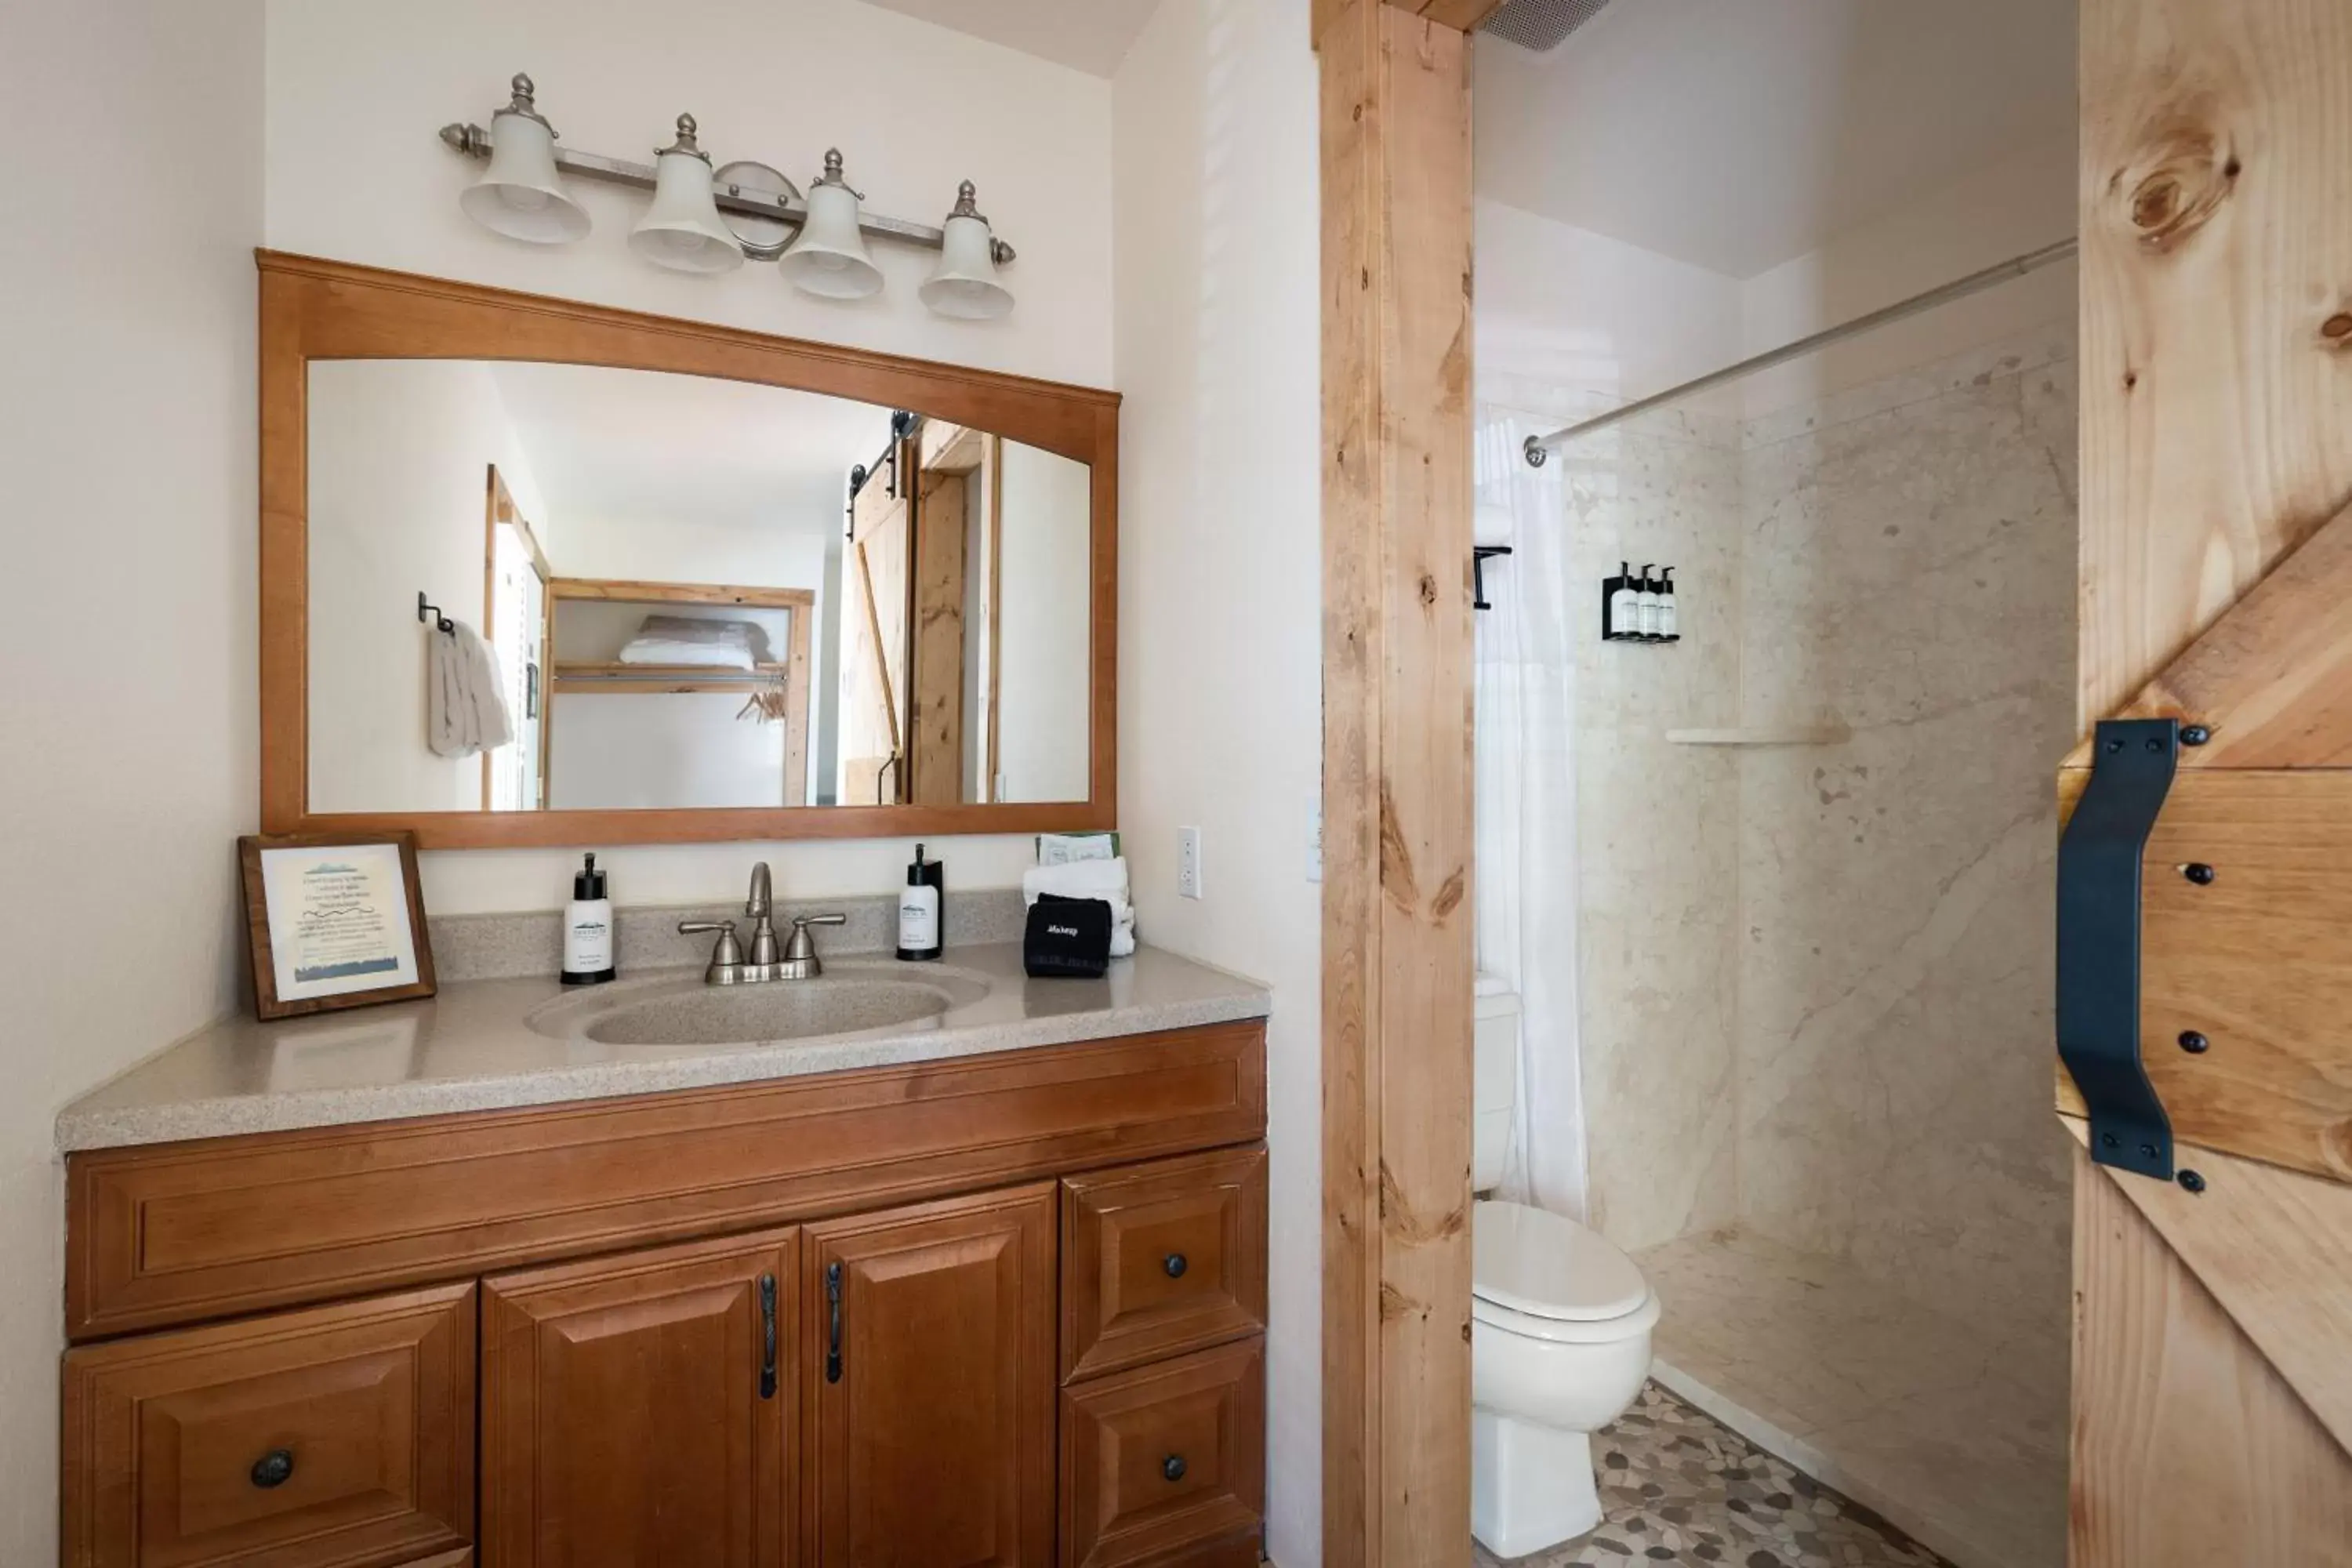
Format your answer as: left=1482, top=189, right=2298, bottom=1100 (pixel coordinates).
left=259, top=252, right=1120, bottom=848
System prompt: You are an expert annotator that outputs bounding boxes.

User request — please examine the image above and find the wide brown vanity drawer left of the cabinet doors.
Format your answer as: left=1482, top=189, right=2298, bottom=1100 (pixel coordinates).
left=64, top=1283, right=475, bottom=1568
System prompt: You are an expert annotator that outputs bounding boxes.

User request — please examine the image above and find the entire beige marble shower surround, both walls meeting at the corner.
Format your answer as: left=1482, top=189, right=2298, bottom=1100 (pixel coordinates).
left=1479, top=325, right=2074, bottom=1375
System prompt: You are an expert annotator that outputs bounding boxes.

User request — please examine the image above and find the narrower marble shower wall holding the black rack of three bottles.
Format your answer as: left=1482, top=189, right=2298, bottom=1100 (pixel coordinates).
left=1482, top=376, right=1740, bottom=1250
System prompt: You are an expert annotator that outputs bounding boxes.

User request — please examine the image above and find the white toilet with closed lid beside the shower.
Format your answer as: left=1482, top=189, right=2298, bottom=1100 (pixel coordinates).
left=1470, top=978, right=1658, bottom=1556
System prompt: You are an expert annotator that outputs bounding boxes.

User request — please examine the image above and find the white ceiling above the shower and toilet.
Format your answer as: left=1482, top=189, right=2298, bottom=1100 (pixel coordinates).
left=1477, top=0, right=2074, bottom=278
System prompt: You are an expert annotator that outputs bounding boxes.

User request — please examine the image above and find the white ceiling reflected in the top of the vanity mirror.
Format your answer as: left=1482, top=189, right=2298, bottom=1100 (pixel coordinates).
left=492, top=362, right=889, bottom=543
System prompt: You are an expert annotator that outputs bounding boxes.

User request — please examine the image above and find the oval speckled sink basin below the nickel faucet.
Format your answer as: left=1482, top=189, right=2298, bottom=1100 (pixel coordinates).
left=579, top=975, right=978, bottom=1046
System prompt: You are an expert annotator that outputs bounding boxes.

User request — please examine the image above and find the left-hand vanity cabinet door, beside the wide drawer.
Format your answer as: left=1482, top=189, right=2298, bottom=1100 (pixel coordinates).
left=482, top=1232, right=800, bottom=1568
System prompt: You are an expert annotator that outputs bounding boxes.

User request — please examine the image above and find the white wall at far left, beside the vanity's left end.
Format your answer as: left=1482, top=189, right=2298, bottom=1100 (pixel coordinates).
left=0, top=0, right=261, bottom=1563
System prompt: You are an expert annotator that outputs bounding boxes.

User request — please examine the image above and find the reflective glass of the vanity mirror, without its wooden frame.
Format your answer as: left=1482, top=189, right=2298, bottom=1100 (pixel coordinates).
left=308, top=360, right=1094, bottom=813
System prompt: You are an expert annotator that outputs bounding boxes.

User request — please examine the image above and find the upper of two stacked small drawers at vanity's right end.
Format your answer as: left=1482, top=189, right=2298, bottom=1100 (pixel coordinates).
left=1061, top=1147, right=1265, bottom=1382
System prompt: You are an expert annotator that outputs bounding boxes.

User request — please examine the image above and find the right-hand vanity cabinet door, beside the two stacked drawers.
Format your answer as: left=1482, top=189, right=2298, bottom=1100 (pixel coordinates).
left=804, top=1185, right=1054, bottom=1568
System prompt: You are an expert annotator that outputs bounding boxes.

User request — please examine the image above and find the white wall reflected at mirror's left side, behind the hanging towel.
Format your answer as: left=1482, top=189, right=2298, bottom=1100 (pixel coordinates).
left=310, top=360, right=553, bottom=811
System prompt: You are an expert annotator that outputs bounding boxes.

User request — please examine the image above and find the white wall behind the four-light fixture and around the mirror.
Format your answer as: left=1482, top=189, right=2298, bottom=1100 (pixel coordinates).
left=266, top=0, right=1110, bottom=914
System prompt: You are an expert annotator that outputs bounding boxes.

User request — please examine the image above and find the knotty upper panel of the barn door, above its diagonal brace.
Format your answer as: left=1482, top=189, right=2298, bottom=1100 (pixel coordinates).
left=2079, top=0, right=2352, bottom=720
